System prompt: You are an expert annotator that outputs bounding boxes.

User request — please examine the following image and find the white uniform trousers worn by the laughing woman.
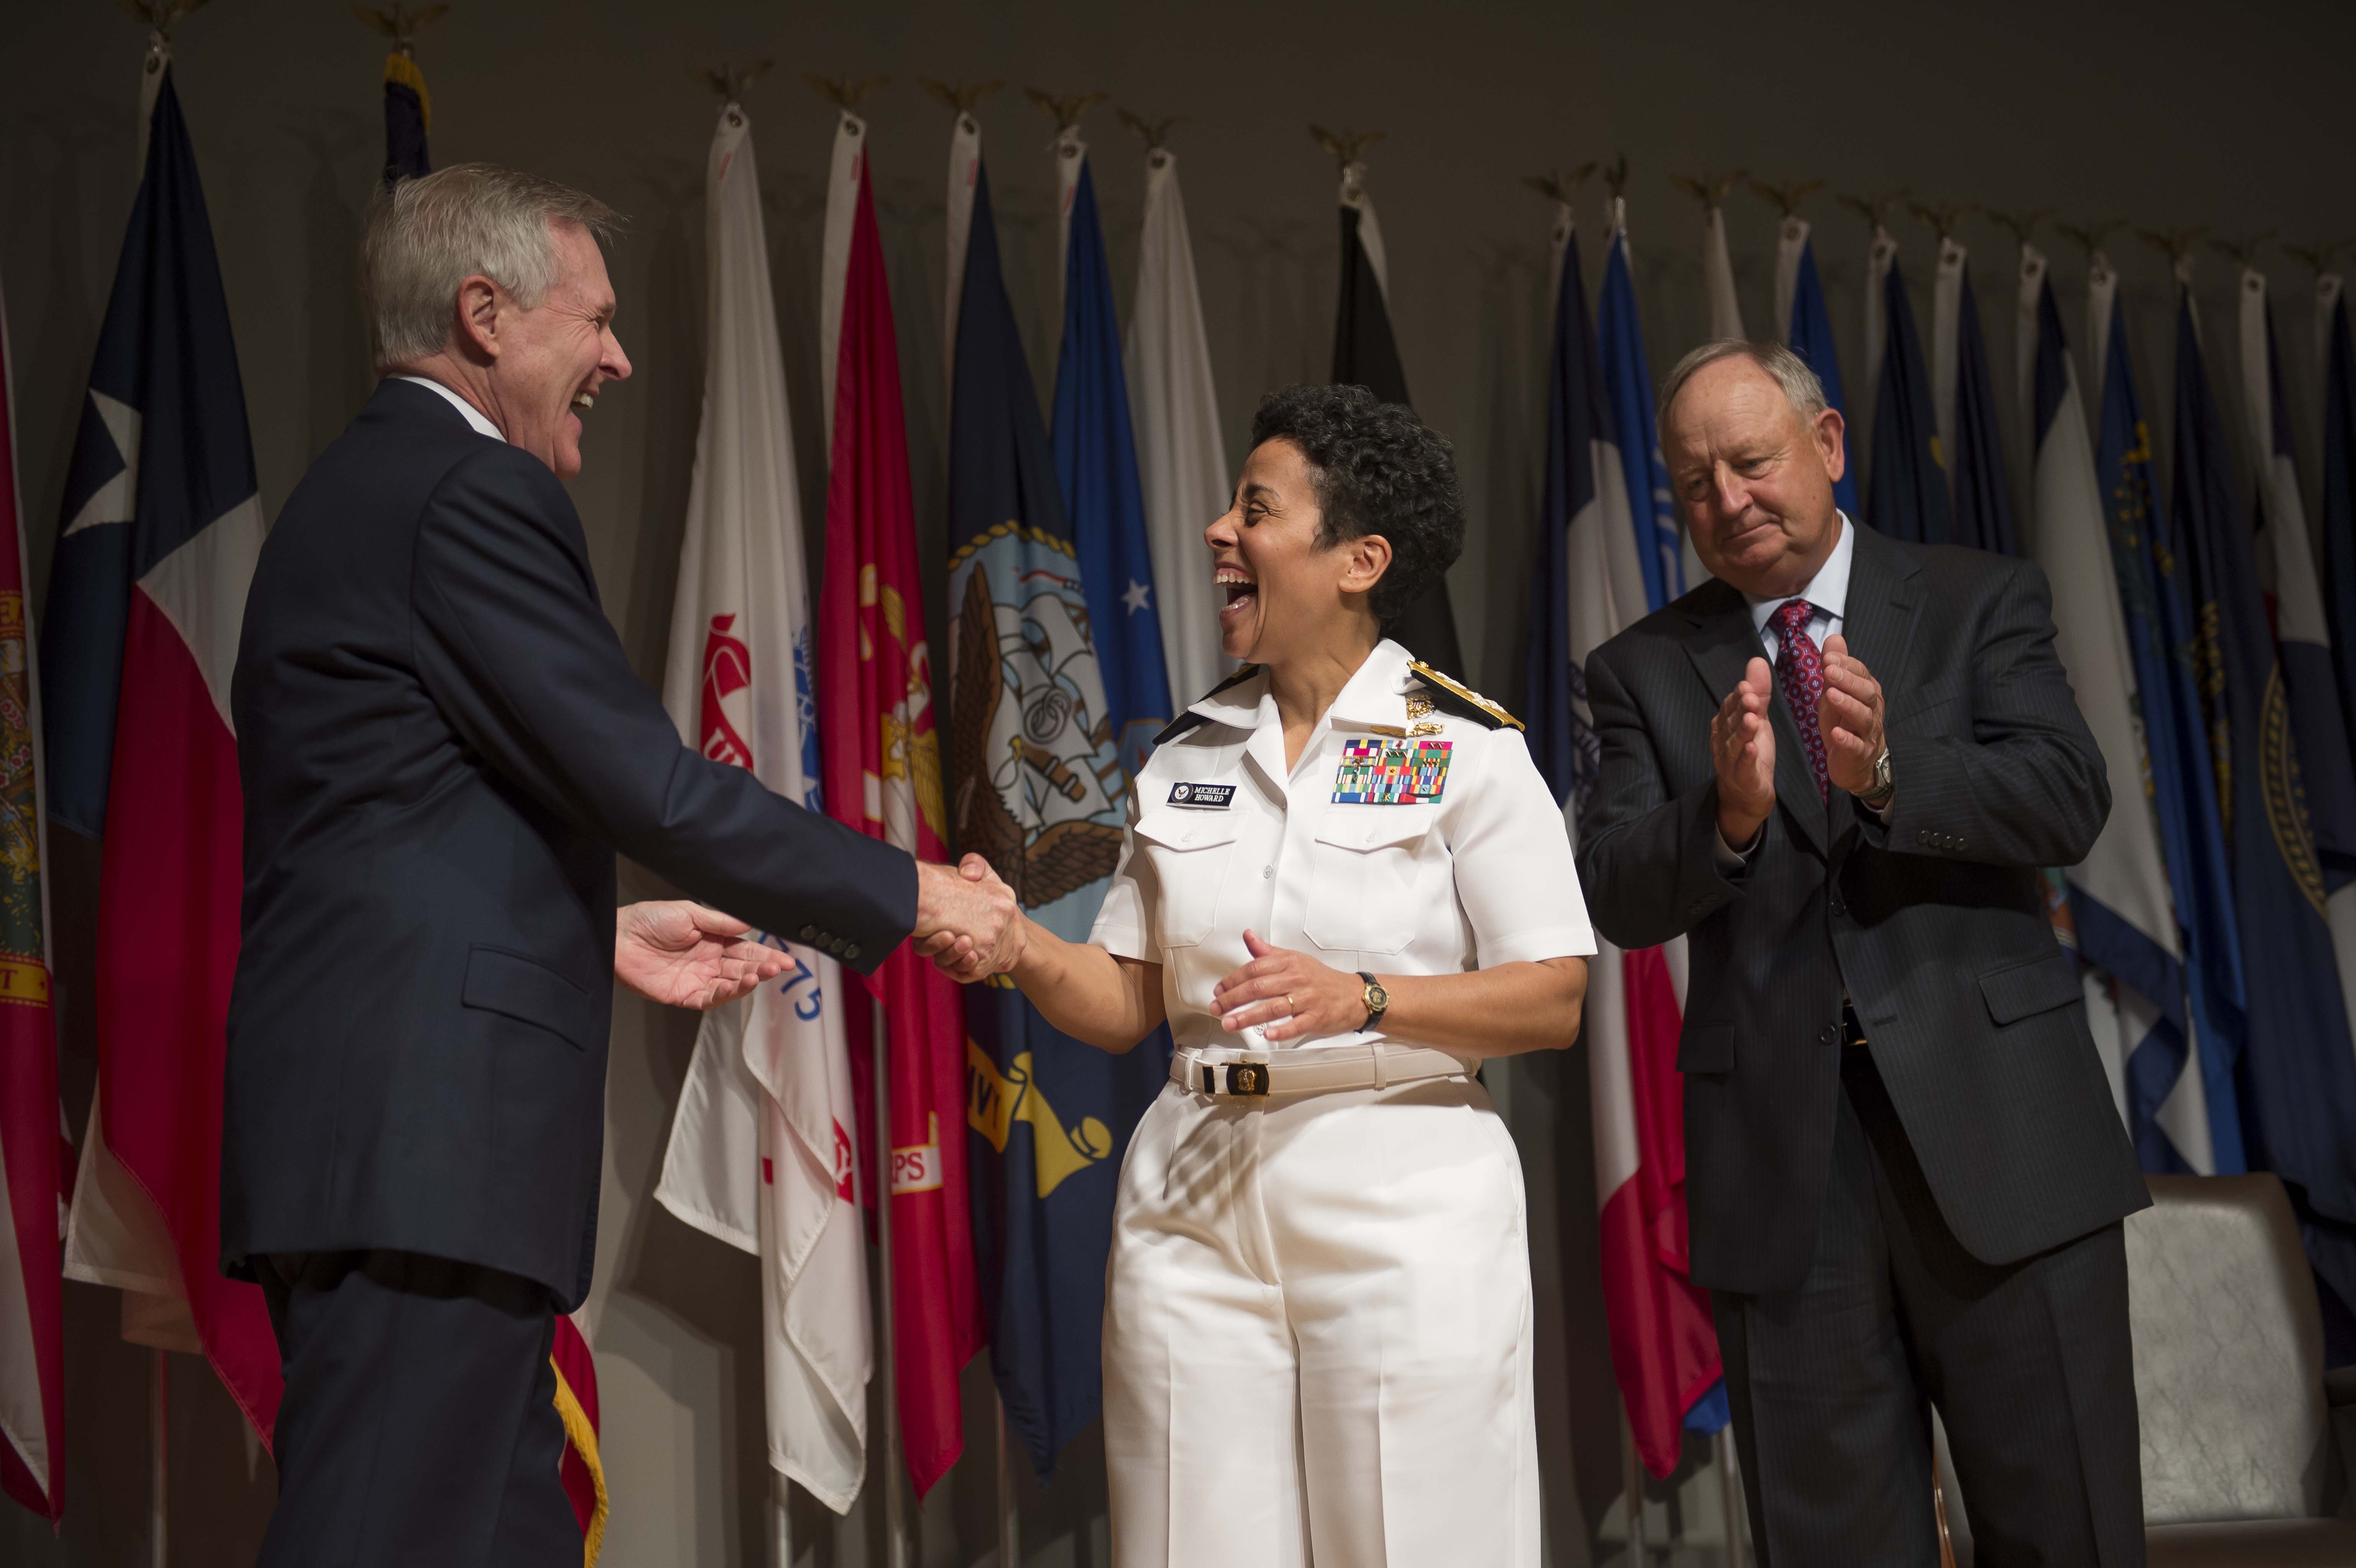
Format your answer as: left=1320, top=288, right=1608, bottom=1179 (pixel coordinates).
left=1105, top=1078, right=1538, bottom=1568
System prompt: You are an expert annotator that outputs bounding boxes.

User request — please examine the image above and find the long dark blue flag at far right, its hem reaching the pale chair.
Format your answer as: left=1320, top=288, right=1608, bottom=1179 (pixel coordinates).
left=2167, top=278, right=2356, bottom=1307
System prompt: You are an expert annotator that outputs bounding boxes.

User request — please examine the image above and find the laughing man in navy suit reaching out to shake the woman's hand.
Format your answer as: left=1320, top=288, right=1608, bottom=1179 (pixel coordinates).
left=222, top=165, right=1015, bottom=1568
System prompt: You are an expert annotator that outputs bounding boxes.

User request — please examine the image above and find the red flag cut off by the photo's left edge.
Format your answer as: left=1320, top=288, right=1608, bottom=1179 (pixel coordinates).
left=0, top=268, right=73, bottom=1523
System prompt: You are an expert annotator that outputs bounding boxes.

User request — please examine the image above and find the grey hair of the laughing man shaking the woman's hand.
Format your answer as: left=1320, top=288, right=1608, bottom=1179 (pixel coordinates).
left=360, top=163, right=622, bottom=374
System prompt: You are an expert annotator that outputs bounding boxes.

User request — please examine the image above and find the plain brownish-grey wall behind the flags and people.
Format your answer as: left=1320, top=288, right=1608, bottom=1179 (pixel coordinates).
left=0, top=0, right=2356, bottom=1568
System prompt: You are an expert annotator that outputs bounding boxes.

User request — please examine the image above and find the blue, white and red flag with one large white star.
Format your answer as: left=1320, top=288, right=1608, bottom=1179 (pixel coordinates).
left=40, top=66, right=280, bottom=1441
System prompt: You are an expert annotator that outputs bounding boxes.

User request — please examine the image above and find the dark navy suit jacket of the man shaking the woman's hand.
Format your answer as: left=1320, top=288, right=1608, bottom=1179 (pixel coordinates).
left=222, top=382, right=916, bottom=1304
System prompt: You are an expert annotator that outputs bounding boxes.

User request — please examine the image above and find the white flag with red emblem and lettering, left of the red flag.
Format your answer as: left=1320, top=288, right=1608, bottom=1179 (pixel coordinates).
left=655, top=104, right=874, bottom=1514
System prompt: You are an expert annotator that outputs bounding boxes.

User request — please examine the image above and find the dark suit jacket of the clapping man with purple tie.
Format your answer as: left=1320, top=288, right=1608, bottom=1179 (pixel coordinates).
left=1578, top=530, right=2149, bottom=1293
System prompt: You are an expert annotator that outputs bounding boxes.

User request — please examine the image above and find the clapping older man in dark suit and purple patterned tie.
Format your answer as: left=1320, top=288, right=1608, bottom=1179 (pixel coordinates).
left=1578, top=341, right=2149, bottom=1568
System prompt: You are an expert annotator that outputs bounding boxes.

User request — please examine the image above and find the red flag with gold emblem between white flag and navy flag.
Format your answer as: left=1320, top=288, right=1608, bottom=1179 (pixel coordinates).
left=818, top=113, right=982, bottom=1497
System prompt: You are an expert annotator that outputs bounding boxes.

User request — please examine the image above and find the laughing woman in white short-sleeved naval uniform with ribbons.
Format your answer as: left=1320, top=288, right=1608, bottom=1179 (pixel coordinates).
left=985, top=386, right=1595, bottom=1568
